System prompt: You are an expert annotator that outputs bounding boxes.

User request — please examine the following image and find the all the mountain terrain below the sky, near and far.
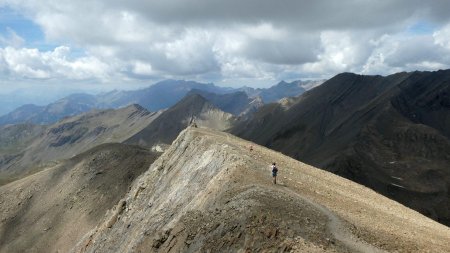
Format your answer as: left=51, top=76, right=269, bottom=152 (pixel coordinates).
left=0, top=70, right=450, bottom=252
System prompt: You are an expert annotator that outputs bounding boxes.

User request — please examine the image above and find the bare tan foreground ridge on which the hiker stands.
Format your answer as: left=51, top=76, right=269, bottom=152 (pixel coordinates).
left=72, top=128, right=450, bottom=252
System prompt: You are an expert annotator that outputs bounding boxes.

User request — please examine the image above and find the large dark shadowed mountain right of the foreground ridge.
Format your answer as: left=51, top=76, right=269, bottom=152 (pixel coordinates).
left=232, top=70, right=450, bottom=224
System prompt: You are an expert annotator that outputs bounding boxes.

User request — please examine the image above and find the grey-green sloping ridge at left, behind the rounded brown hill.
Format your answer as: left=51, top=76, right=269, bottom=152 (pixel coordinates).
left=0, top=105, right=159, bottom=178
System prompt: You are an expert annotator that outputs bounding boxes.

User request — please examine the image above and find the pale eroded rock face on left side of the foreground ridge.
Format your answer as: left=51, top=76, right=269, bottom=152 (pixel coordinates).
left=73, top=129, right=255, bottom=252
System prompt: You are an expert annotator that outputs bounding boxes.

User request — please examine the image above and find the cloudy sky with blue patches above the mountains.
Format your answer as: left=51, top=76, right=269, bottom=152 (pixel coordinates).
left=0, top=0, right=450, bottom=92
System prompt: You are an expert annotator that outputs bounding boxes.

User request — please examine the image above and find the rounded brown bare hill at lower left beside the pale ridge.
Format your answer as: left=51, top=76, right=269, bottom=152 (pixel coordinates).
left=0, top=144, right=157, bottom=252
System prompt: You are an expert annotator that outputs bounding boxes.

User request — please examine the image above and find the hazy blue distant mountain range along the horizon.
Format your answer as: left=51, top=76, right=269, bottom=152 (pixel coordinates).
left=0, top=80, right=320, bottom=125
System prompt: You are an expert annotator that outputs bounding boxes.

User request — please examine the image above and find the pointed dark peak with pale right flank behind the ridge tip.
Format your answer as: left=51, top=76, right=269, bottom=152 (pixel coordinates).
left=125, top=94, right=235, bottom=147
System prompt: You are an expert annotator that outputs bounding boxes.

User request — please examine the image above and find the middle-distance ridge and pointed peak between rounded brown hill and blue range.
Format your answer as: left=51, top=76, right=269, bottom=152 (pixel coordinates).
left=0, top=94, right=236, bottom=182
